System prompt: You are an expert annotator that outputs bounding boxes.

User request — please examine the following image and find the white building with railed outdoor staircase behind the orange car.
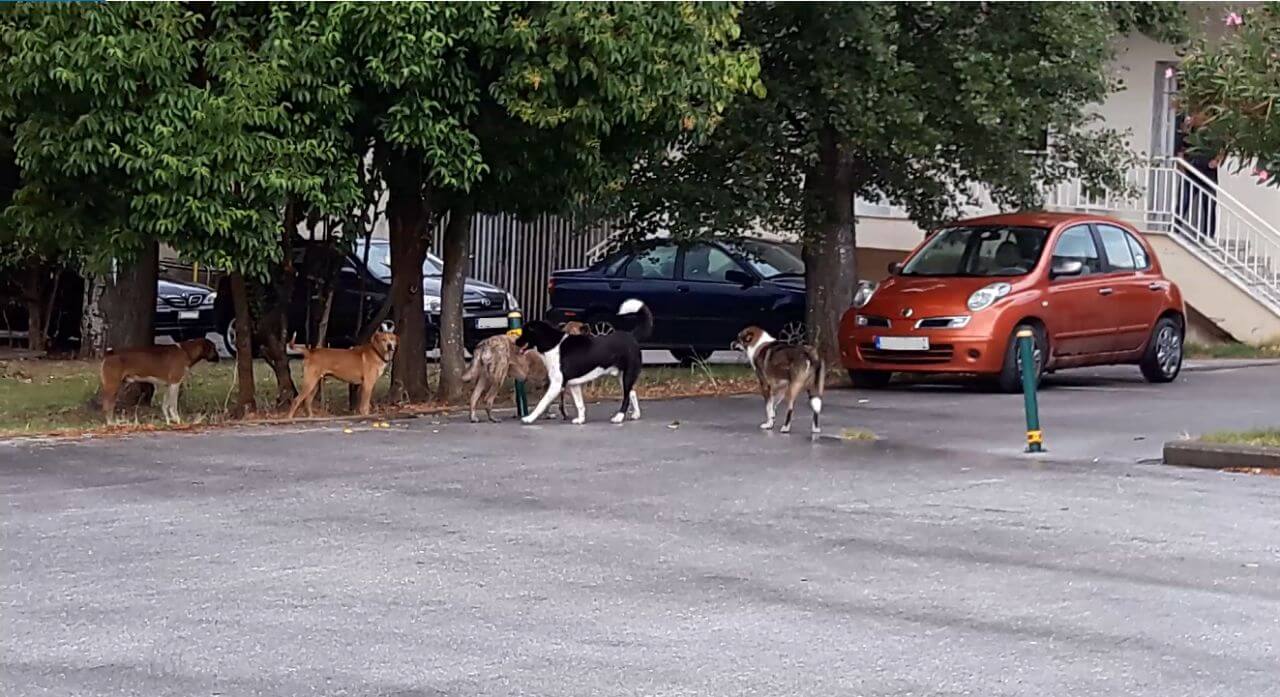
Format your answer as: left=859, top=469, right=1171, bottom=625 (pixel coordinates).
left=856, top=3, right=1280, bottom=343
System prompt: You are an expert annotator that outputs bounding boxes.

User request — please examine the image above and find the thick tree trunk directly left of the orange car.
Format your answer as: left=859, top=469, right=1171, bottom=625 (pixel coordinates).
left=804, top=128, right=858, bottom=366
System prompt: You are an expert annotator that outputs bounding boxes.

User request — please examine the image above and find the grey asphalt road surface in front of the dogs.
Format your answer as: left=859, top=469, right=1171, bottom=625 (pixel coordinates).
left=0, top=367, right=1280, bottom=697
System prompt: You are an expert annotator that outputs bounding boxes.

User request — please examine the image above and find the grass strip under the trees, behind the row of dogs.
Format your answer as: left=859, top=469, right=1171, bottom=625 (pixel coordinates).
left=0, top=359, right=756, bottom=436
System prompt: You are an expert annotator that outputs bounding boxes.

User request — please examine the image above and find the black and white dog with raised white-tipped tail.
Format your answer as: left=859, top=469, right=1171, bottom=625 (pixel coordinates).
left=516, top=299, right=653, bottom=423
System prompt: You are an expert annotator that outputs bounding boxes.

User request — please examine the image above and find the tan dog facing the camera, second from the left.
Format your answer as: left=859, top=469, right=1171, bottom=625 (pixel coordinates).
left=289, top=322, right=399, bottom=418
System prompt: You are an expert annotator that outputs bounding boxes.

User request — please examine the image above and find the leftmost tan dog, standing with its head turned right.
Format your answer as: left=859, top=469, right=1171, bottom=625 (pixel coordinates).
left=100, top=339, right=218, bottom=423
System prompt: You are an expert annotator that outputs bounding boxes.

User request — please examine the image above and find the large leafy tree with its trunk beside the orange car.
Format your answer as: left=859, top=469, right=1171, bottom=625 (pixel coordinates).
left=599, top=3, right=1181, bottom=363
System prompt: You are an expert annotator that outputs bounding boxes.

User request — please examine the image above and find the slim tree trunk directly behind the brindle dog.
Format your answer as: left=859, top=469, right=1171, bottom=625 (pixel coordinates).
left=439, top=202, right=471, bottom=402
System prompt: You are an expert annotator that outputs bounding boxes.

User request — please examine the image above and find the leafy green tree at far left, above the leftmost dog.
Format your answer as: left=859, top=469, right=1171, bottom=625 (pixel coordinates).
left=0, top=4, right=355, bottom=411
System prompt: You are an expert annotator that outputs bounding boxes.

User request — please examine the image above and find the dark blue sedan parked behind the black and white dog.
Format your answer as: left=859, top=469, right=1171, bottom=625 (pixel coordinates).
left=548, top=239, right=805, bottom=362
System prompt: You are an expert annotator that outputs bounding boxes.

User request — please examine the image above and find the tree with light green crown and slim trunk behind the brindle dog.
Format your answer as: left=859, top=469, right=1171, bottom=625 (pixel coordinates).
left=438, top=3, right=758, bottom=399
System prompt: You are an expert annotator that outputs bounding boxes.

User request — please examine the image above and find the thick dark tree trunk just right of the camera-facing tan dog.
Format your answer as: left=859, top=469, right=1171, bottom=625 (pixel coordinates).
left=387, top=157, right=430, bottom=402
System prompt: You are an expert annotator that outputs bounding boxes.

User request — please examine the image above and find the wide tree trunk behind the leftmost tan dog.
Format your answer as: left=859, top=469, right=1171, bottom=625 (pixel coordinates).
left=81, top=242, right=160, bottom=408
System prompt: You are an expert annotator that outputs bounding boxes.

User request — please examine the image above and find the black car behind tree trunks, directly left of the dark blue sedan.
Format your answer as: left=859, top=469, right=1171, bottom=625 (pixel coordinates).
left=218, top=239, right=518, bottom=353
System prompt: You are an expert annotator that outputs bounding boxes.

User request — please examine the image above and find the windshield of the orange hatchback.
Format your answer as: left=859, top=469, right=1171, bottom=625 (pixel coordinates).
left=901, top=225, right=1048, bottom=276
